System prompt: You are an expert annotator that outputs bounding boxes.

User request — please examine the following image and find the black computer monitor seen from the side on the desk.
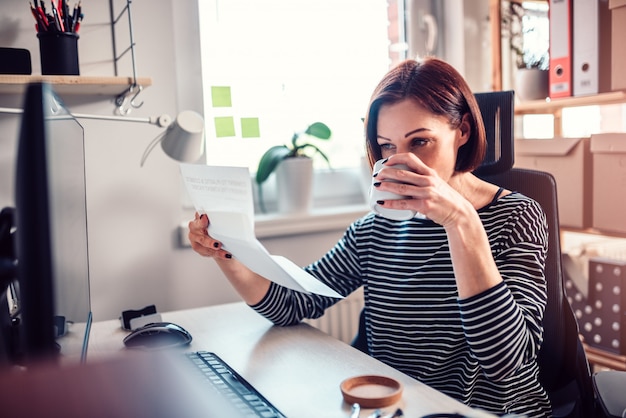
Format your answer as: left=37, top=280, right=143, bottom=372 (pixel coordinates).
left=8, top=83, right=91, bottom=365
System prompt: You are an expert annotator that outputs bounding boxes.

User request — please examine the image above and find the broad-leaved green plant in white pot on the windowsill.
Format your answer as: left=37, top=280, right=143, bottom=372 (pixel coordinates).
left=256, top=122, right=331, bottom=212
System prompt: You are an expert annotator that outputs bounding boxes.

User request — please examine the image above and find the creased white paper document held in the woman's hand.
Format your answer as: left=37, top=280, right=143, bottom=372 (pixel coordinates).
left=180, top=163, right=343, bottom=298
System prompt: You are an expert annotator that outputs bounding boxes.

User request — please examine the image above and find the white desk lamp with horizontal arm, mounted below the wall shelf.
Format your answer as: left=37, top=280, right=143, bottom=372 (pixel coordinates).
left=0, top=107, right=204, bottom=166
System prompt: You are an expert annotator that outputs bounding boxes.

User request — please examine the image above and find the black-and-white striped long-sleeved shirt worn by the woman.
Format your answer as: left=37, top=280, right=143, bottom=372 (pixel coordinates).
left=253, top=193, right=551, bottom=417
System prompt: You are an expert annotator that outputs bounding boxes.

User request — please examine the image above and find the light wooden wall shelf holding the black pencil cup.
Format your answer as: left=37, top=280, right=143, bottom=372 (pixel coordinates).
left=0, top=75, right=152, bottom=96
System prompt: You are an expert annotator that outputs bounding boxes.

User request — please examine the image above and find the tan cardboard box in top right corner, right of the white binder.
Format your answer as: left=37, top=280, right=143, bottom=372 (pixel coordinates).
left=609, top=0, right=626, bottom=90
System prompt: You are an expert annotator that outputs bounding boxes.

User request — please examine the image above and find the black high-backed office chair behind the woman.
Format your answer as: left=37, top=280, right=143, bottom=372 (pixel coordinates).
left=352, top=91, right=595, bottom=418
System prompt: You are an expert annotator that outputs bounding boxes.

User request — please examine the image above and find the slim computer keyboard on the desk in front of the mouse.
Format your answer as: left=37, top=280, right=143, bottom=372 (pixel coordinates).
left=185, top=351, right=285, bottom=418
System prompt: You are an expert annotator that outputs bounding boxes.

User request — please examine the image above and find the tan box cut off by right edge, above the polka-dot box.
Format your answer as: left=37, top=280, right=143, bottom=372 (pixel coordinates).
left=591, top=133, right=626, bottom=233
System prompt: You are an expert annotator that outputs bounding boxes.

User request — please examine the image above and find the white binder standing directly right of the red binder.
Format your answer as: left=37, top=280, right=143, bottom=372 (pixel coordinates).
left=572, top=0, right=611, bottom=96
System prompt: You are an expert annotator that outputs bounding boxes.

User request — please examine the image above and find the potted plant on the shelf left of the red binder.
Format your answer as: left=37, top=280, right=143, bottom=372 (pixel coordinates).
left=502, top=1, right=550, bottom=100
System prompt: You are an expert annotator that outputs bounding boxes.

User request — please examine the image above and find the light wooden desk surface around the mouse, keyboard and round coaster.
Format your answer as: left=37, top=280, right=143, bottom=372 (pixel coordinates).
left=0, top=303, right=491, bottom=418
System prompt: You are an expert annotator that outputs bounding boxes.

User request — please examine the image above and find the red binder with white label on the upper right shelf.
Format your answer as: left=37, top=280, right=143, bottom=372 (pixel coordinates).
left=549, top=0, right=573, bottom=98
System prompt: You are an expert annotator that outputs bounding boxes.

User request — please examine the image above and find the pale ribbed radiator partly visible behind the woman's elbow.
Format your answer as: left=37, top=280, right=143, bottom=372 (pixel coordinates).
left=305, top=289, right=363, bottom=344
